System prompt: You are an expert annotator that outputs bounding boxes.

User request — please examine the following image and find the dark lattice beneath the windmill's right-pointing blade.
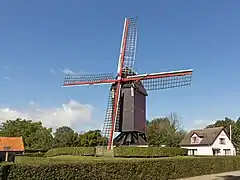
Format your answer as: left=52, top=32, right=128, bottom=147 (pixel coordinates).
left=141, top=75, right=192, bottom=91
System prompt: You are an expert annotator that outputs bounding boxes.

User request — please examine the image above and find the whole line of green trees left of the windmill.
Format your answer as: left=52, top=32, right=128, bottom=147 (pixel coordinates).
left=0, top=118, right=107, bottom=152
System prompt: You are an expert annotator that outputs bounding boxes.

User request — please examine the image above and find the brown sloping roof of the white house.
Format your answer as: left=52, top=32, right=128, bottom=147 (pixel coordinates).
left=179, top=127, right=224, bottom=146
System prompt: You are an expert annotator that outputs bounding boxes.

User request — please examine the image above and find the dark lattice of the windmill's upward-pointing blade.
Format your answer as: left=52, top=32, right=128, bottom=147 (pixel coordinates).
left=123, top=17, right=138, bottom=69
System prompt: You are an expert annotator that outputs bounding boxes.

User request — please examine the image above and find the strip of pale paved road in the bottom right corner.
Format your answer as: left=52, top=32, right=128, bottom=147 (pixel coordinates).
left=179, top=171, right=240, bottom=180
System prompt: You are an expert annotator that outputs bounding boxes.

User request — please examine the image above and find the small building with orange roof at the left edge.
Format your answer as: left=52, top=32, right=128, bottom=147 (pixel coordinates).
left=0, top=137, right=24, bottom=162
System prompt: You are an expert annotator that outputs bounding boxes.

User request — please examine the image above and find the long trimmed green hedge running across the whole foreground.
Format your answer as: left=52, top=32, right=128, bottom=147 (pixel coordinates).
left=2, top=157, right=240, bottom=180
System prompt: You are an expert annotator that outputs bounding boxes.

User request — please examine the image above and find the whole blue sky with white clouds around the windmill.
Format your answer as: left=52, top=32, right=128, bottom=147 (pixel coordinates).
left=0, top=0, right=240, bottom=131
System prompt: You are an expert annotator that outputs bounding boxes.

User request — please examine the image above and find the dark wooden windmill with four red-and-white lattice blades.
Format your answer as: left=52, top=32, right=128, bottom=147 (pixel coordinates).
left=63, top=17, right=192, bottom=150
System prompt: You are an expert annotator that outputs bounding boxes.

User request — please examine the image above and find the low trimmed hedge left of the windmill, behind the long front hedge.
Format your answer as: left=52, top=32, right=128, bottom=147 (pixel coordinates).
left=45, top=147, right=95, bottom=157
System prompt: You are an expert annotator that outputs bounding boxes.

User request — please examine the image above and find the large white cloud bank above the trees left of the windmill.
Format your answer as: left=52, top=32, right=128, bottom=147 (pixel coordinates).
left=0, top=100, right=93, bottom=129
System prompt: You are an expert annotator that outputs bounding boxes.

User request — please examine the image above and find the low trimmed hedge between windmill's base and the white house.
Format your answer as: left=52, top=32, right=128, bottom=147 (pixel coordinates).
left=114, top=146, right=187, bottom=157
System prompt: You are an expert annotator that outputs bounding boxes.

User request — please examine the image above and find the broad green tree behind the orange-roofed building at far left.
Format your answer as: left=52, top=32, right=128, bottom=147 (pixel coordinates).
left=0, top=118, right=53, bottom=149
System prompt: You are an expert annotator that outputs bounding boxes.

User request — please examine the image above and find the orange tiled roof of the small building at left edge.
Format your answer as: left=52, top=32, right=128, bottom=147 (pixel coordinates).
left=0, top=137, right=24, bottom=151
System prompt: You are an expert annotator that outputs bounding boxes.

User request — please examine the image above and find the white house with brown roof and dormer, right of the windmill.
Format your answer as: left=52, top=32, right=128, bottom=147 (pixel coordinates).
left=180, top=127, right=236, bottom=156
